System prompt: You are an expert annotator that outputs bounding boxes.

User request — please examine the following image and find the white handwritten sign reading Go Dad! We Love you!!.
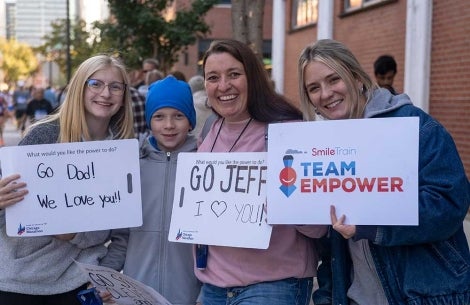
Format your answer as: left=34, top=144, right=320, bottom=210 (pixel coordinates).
left=0, top=139, right=142, bottom=236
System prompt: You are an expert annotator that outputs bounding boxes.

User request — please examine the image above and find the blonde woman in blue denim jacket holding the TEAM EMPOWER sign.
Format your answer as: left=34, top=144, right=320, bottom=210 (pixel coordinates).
left=298, top=39, right=470, bottom=305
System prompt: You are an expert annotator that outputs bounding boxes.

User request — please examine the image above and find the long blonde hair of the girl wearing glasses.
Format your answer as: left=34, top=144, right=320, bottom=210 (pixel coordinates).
left=31, top=55, right=134, bottom=143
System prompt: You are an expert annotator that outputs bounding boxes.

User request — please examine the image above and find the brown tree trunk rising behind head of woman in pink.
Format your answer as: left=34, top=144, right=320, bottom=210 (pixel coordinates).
left=232, top=0, right=265, bottom=60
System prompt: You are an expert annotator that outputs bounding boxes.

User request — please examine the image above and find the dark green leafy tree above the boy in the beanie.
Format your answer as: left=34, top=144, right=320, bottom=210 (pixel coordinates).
left=95, top=0, right=218, bottom=71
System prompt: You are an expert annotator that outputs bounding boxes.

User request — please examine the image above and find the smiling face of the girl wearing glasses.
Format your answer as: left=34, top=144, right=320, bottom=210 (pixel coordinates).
left=84, top=67, right=125, bottom=125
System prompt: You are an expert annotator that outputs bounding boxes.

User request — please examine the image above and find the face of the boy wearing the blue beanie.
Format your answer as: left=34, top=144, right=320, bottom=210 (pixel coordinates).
left=150, top=107, right=191, bottom=152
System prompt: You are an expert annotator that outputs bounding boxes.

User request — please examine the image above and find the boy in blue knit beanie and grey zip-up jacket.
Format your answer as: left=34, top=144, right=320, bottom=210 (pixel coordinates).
left=101, top=76, right=201, bottom=305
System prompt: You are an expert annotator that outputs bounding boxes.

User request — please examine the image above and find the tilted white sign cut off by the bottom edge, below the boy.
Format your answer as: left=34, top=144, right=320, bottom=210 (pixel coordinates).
left=75, top=262, right=173, bottom=305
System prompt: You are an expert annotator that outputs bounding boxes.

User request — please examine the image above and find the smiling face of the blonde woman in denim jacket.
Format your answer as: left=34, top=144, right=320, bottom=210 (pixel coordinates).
left=304, top=61, right=352, bottom=120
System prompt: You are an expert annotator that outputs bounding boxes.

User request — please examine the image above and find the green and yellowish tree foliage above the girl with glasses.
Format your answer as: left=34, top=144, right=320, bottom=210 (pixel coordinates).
left=36, top=0, right=218, bottom=74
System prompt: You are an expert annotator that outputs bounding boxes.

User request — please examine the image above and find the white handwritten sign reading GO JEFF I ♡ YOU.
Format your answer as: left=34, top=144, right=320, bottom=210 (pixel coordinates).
left=168, top=153, right=272, bottom=249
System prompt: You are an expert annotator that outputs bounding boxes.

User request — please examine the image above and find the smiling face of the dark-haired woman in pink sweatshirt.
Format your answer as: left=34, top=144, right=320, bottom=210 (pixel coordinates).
left=204, top=53, right=250, bottom=122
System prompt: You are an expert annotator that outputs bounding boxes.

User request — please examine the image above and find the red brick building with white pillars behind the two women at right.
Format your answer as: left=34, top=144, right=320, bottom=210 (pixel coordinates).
left=173, top=0, right=470, bottom=238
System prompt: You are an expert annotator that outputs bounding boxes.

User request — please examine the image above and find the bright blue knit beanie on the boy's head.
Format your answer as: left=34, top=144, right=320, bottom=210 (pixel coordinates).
left=145, top=75, right=196, bottom=129
